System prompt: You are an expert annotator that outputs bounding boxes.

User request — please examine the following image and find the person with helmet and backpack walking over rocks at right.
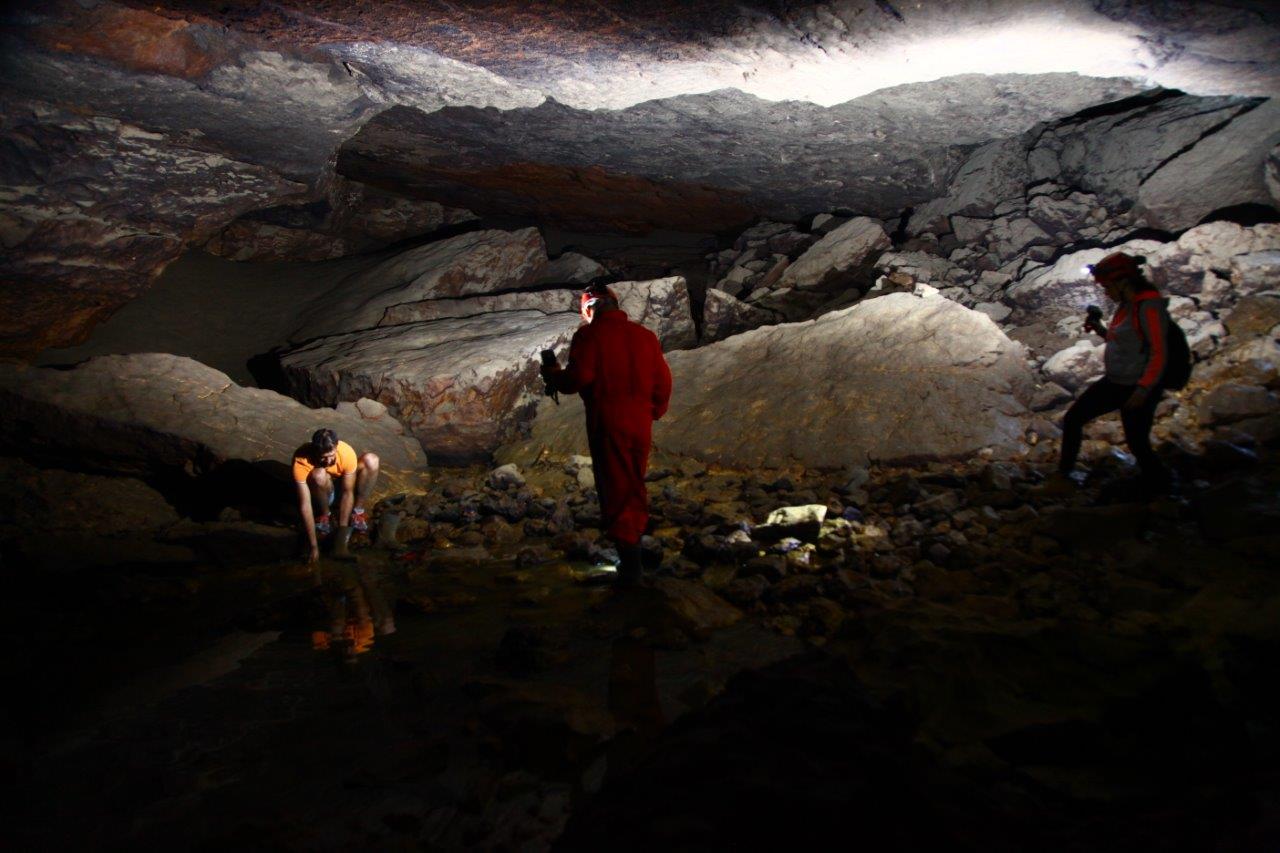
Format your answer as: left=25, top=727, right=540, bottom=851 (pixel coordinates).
left=1059, top=252, right=1171, bottom=491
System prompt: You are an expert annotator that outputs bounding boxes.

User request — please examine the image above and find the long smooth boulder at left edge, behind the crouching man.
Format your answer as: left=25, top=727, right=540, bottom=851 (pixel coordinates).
left=0, top=353, right=426, bottom=476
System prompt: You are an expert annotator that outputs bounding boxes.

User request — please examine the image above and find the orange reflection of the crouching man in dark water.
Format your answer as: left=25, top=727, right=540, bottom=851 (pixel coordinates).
left=311, top=561, right=396, bottom=663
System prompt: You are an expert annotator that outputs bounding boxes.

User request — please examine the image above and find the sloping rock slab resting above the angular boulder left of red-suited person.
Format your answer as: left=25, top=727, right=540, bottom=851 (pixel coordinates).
left=293, top=228, right=547, bottom=341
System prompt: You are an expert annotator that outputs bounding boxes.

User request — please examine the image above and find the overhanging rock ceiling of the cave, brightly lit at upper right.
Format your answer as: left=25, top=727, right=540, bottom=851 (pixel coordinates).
left=0, top=0, right=1280, bottom=348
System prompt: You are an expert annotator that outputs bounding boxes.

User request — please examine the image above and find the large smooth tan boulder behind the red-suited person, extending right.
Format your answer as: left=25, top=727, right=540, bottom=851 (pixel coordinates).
left=498, top=293, right=1034, bottom=467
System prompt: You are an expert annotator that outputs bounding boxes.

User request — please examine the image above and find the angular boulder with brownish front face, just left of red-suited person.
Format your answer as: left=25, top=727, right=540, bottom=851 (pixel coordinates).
left=280, top=310, right=580, bottom=461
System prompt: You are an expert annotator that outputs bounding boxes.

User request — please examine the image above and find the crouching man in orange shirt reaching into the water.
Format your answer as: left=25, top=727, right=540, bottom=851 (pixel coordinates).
left=293, top=429, right=378, bottom=564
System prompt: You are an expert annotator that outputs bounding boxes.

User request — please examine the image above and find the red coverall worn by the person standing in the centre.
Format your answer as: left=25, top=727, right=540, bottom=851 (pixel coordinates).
left=553, top=310, right=671, bottom=546
